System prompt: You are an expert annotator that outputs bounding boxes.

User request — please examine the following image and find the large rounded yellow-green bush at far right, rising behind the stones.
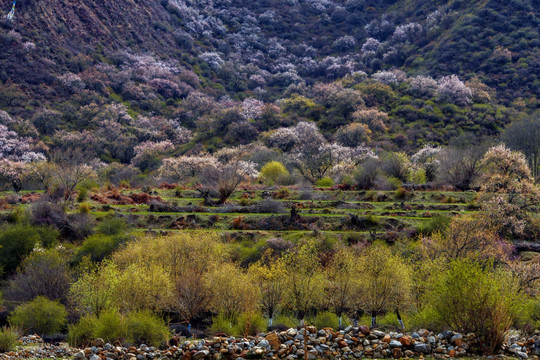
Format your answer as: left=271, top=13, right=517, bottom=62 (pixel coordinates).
left=427, top=259, right=522, bottom=354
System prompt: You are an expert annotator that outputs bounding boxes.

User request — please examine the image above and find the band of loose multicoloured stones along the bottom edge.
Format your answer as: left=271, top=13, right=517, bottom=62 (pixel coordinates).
left=0, top=326, right=540, bottom=360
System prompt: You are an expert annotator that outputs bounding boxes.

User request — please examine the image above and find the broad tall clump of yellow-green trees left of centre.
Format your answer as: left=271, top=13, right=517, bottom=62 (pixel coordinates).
left=71, top=234, right=230, bottom=319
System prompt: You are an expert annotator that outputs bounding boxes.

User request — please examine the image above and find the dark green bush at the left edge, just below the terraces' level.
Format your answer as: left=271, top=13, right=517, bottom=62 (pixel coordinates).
left=0, top=224, right=59, bottom=273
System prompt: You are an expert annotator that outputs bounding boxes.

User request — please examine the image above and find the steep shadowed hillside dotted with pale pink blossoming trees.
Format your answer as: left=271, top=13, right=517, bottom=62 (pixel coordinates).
left=0, top=0, right=540, bottom=162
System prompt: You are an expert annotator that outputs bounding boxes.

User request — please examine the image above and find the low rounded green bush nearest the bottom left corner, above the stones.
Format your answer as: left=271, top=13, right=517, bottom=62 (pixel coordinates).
left=9, top=296, right=67, bottom=335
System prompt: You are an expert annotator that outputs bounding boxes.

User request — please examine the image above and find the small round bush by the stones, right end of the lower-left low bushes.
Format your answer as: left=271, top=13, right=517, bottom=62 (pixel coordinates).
left=125, top=311, right=169, bottom=347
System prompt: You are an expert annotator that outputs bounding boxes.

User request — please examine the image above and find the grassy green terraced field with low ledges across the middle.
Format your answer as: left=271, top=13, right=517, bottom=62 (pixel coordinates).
left=73, top=188, right=477, bottom=240
